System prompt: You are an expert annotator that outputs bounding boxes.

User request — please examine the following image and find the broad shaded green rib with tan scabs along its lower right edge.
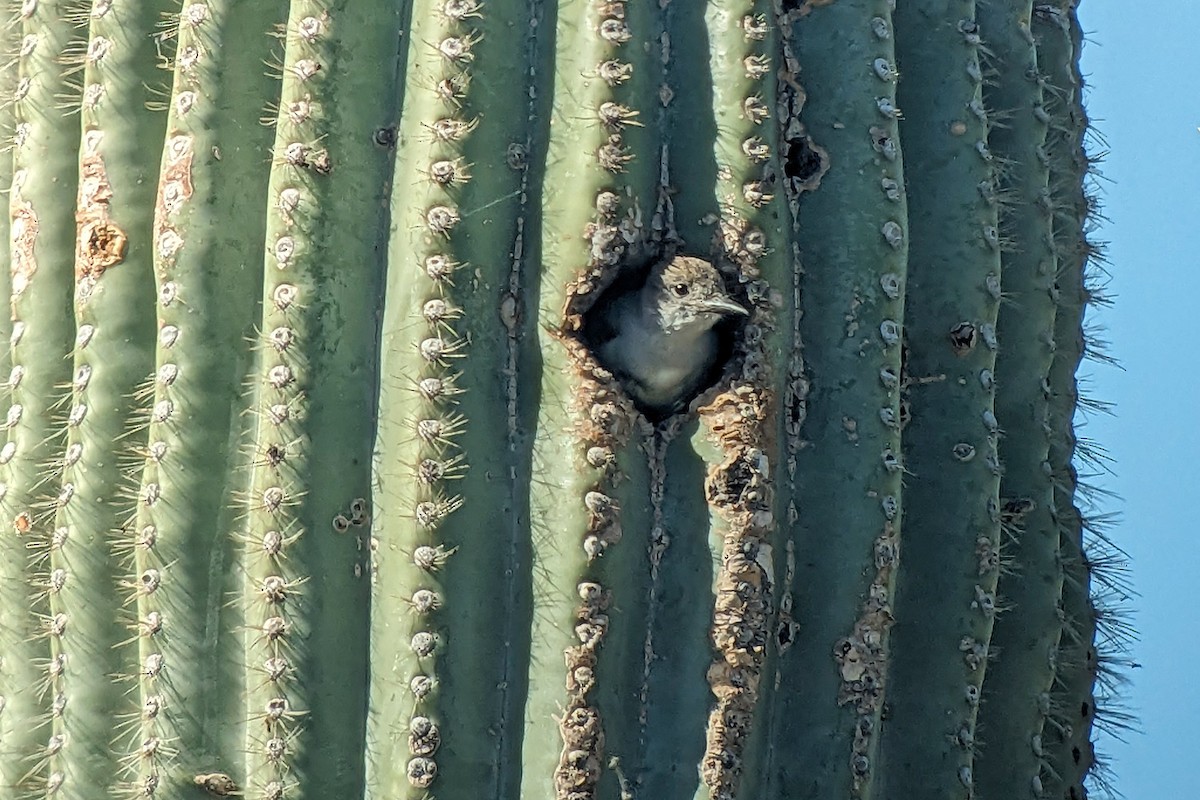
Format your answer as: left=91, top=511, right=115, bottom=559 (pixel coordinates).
left=772, top=2, right=908, bottom=798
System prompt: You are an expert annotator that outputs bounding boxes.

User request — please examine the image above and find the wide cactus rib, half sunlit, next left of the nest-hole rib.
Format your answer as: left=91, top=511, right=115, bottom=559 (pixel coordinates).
left=368, top=0, right=533, bottom=798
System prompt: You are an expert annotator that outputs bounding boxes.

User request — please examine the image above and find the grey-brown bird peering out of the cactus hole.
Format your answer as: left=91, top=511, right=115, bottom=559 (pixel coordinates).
left=593, top=255, right=750, bottom=419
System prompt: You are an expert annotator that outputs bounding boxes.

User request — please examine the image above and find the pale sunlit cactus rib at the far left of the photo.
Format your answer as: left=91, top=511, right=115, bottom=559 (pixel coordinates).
left=0, top=2, right=84, bottom=793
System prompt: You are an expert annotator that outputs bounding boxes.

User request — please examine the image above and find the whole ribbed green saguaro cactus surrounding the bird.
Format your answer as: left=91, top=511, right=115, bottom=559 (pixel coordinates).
left=0, top=0, right=1120, bottom=800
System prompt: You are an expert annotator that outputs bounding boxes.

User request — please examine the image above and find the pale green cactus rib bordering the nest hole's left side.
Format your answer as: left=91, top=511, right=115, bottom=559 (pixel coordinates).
left=521, top=0, right=661, bottom=796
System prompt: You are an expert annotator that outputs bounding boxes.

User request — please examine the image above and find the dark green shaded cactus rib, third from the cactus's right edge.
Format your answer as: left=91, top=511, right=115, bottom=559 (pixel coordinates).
left=880, top=0, right=1002, bottom=798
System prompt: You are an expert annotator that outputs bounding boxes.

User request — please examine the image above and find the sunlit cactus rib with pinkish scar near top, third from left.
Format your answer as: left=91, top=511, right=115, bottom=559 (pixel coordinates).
left=124, top=0, right=270, bottom=798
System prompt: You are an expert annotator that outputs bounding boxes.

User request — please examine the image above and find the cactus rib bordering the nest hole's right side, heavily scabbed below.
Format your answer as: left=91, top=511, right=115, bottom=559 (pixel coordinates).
left=686, top=0, right=797, bottom=798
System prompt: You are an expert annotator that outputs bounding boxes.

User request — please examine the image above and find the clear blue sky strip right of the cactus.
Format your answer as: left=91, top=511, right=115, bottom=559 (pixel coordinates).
left=1079, top=0, right=1200, bottom=800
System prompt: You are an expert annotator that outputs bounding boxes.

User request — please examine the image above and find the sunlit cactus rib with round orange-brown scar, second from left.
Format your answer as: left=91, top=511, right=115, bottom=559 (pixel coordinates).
left=55, top=0, right=173, bottom=796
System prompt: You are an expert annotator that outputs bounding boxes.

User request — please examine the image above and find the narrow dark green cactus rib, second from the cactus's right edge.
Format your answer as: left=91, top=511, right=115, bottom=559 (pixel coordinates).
left=974, top=2, right=1062, bottom=796
